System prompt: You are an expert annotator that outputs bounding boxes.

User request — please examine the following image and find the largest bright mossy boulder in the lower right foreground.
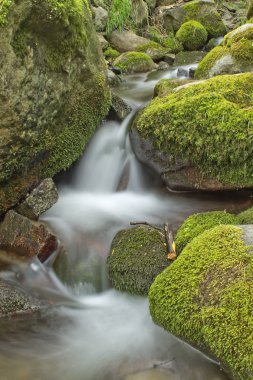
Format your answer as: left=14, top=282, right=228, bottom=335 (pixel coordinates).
left=149, top=225, right=253, bottom=380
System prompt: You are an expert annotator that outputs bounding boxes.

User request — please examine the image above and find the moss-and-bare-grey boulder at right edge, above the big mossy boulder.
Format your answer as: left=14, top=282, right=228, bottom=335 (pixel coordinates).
left=195, top=24, right=253, bottom=79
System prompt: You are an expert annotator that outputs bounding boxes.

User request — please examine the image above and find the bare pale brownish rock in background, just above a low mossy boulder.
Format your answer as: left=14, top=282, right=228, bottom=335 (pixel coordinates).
left=109, top=30, right=150, bottom=53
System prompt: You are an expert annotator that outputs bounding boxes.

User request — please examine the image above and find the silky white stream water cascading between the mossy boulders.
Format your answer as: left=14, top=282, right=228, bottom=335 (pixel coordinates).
left=0, top=68, right=252, bottom=380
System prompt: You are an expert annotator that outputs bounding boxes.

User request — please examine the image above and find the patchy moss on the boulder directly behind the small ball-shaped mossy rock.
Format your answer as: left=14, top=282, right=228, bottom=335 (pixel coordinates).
left=183, top=0, right=226, bottom=37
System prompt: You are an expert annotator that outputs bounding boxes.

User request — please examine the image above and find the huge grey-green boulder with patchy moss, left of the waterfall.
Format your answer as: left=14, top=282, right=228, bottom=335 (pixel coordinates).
left=0, top=0, right=110, bottom=214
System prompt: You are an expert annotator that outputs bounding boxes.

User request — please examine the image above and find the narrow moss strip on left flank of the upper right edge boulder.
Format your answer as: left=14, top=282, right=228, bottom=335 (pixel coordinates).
left=194, top=46, right=230, bottom=79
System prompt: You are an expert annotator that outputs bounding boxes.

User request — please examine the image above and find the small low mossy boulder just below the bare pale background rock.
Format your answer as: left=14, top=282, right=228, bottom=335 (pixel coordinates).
left=114, top=51, right=156, bottom=74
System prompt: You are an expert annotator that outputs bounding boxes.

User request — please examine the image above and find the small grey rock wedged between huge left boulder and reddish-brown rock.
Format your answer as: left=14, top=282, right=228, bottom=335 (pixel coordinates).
left=17, top=178, right=58, bottom=220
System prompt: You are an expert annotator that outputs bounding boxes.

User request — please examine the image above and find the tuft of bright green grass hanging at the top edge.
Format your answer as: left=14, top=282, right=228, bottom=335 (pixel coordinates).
left=106, top=0, right=132, bottom=35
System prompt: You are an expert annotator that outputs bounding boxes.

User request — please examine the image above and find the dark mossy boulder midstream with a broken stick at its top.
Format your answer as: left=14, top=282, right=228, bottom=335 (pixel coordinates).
left=107, top=226, right=170, bottom=295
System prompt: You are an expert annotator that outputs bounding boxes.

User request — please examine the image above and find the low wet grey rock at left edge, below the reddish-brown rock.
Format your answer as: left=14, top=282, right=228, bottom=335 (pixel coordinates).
left=0, top=279, right=42, bottom=318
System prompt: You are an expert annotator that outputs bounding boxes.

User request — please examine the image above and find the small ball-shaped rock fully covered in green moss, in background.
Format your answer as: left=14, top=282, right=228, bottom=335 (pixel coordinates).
left=176, top=20, right=207, bottom=50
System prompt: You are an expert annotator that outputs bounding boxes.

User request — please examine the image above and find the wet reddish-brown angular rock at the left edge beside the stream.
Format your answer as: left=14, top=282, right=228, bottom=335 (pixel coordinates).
left=0, top=210, right=58, bottom=262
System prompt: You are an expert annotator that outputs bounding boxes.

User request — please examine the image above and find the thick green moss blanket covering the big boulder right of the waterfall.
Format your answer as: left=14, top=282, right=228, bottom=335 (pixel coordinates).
left=136, top=73, right=253, bottom=186
